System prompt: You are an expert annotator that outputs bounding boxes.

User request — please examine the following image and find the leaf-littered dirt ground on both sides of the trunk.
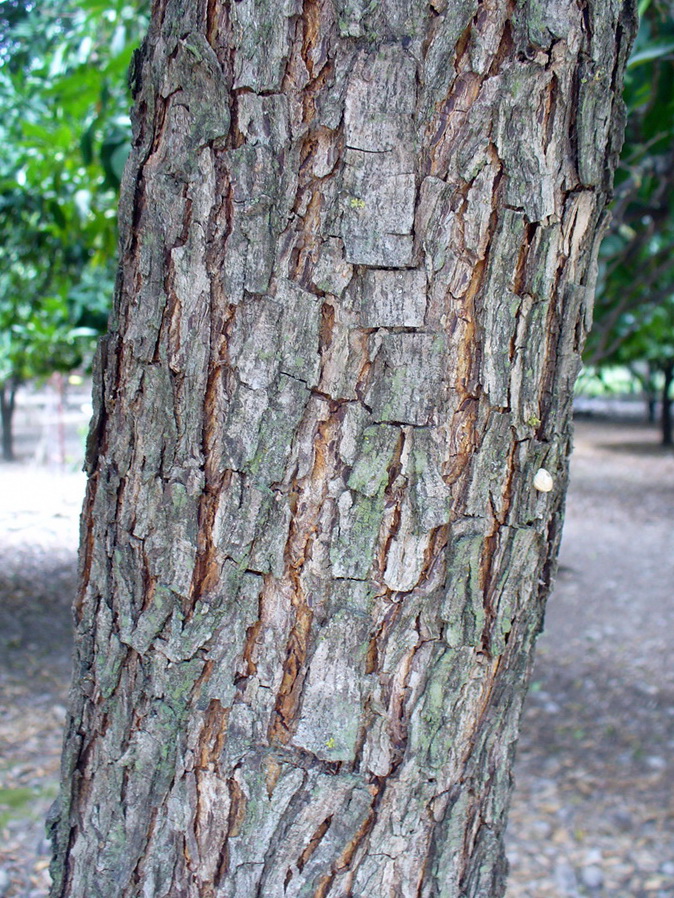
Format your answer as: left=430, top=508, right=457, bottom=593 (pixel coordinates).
left=0, top=422, right=674, bottom=898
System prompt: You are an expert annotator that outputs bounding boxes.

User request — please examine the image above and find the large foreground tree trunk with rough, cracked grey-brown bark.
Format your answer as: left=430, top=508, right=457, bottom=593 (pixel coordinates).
left=52, top=0, right=635, bottom=898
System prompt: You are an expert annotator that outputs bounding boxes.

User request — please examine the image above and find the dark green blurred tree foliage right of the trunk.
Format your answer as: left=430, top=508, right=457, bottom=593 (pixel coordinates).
left=585, top=0, right=674, bottom=445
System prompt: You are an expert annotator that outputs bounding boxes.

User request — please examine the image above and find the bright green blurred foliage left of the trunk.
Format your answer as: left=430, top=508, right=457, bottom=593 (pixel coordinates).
left=0, top=0, right=147, bottom=383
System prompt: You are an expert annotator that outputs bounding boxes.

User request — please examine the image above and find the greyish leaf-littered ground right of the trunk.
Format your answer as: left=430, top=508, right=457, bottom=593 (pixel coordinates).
left=508, top=422, right=674, bottom=898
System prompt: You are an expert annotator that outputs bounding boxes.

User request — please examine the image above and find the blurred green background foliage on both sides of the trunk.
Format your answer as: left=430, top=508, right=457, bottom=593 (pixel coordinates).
left=0, top=0, right=674, bottom=460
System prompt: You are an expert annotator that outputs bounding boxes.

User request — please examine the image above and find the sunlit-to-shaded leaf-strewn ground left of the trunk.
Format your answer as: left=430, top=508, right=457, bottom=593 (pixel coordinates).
left=0, top=465, right=84, bottom=898
